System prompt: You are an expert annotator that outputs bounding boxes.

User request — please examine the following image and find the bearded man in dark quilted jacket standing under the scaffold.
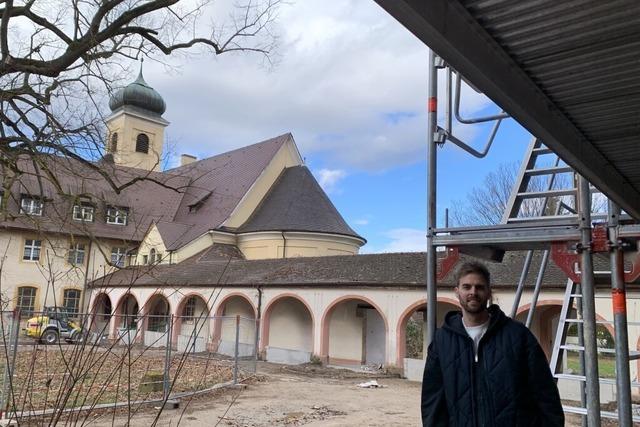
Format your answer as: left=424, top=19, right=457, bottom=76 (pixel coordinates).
left=422, top=262, right=564, bottom=427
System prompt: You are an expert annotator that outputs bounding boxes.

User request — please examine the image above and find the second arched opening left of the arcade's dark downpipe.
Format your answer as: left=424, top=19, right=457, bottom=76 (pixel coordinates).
left=175, top=295, right=210, bottom=353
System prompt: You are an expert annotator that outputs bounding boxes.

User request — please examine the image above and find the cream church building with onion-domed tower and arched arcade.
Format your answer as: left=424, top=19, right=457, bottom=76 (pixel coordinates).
left=0, top=70, right=640, bottom=402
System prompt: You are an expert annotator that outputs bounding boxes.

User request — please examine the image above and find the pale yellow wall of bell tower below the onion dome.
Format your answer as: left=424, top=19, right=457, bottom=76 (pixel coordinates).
left=107, top=112, right=167, bottom=171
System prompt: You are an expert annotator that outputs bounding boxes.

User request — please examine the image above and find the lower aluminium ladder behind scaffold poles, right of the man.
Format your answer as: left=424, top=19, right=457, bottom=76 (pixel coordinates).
left=550, top=279, right=640, bottom=423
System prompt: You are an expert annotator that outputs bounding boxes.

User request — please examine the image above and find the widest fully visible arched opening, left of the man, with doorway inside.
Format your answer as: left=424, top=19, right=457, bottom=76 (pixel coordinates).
left=322, top=296, right=388, bottom=366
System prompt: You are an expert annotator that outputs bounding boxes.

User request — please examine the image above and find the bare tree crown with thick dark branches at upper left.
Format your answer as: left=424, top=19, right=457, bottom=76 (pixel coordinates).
left=0, top=0, right=280, bottom=192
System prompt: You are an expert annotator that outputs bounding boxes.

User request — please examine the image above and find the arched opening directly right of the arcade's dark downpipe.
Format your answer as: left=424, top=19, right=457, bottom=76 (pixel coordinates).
left=262, top=295, right=314, bottom=364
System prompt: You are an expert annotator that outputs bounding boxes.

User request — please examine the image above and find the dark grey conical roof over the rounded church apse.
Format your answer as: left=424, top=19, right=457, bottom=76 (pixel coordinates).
left=238, top=166, right=364, bottom=240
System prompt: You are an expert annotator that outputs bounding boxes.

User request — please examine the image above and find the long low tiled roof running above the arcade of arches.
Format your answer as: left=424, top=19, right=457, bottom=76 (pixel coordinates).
left=92, top=252, right=567, bottom=288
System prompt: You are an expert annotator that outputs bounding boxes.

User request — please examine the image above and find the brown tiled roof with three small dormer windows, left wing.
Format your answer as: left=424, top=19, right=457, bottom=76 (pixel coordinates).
left=0, top=156, right=189, bottom=241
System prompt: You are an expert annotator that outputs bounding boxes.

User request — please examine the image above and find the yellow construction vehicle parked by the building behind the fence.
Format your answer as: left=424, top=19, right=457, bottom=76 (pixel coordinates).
left=24, top=307, right=84, bottom=344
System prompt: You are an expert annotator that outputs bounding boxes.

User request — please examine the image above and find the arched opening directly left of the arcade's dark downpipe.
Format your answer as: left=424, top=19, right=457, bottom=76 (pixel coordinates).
left=214, top=294, right=256, bottom=357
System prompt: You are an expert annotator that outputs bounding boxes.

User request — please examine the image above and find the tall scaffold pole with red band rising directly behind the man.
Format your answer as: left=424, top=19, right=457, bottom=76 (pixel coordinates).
left=426, top=50, right=438, bottom=345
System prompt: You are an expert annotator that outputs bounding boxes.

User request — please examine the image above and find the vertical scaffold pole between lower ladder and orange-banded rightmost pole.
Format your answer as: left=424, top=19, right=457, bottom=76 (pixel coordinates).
left=578, top=176, right=600, bottom=427
